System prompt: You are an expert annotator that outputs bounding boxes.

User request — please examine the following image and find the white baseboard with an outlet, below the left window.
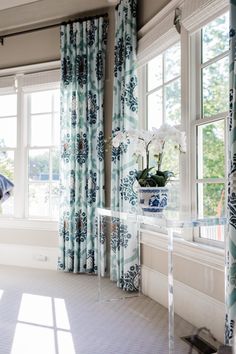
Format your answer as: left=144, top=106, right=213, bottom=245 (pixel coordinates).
left=0, top=244, right=58, bottom=270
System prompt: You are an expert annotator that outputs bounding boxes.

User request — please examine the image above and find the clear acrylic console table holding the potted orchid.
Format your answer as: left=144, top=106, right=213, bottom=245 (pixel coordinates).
left=97, top=208, right=227, bottom=354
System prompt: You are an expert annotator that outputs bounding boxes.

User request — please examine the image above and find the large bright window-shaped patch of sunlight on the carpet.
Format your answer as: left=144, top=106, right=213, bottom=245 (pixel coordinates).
left=10, top=292, right=75, bottom=354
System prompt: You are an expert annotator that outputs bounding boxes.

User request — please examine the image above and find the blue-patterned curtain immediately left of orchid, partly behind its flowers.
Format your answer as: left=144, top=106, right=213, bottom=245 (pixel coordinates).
left=110, top=0, right=139, bottom=291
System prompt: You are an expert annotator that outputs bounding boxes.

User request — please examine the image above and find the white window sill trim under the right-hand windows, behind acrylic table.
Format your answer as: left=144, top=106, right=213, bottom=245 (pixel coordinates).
left=141, top=229, right=225, bottom=272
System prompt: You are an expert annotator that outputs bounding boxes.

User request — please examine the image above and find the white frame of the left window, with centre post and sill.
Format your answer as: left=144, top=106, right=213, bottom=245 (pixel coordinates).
left=0, top=61, right=60, bottom=230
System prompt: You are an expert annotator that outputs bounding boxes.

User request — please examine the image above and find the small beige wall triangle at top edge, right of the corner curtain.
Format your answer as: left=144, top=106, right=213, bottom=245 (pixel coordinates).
left=138, top=0, right=170, bottom=29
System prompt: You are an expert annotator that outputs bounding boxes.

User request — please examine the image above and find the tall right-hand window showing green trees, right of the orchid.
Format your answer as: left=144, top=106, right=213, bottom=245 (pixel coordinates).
left=193, top=13, right=229, bottom=241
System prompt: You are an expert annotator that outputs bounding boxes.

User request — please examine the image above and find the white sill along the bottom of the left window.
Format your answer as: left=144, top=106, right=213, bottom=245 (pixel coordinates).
left=0, top=217, right=58, bottom=231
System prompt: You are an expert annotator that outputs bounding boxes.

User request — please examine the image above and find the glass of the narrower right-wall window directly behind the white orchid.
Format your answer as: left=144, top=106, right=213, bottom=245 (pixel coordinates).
left=146, top=42, right=181, bottom=178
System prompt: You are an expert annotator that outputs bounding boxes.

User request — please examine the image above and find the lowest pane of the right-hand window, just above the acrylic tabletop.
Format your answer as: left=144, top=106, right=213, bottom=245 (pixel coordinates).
left=198, top=183, right=225, bottom=218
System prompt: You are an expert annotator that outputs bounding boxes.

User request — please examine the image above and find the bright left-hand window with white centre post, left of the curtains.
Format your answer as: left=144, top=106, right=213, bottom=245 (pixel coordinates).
left=0, top=70, right=60, bottom=220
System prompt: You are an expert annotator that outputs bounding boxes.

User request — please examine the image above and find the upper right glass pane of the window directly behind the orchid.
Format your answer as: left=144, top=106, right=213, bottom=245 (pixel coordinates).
left=164, top=42, right=180, bottom=82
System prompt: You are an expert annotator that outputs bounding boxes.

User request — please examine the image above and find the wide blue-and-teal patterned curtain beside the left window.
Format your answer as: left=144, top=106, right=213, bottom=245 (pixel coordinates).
left=58, top=16, right=108, bottom=273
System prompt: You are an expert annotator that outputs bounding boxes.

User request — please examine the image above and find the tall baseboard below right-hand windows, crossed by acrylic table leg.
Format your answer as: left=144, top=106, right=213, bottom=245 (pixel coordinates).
left=142, top=266, right=225, bottom=342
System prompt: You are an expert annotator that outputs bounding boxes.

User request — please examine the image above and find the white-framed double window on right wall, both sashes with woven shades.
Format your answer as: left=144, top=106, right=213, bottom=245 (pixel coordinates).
left=138, top=4, right=229, bottom=247
